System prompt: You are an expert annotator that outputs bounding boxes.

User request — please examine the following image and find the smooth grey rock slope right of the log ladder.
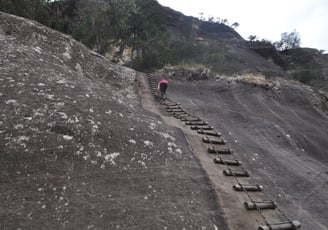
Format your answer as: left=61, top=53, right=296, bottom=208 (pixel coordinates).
left=161, top=79, right=328, bottom=230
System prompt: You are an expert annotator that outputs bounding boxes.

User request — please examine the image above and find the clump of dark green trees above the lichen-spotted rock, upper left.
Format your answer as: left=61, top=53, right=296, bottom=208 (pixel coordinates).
left=0, top=0, right=174, bottom=70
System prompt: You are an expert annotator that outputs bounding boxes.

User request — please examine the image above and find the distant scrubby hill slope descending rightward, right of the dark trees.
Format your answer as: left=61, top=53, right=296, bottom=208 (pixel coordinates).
left=155, top=7, right=283, bottom=75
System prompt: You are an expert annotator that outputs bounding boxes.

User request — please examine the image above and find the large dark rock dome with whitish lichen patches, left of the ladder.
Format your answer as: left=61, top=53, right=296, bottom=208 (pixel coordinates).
left=0, top=13, right=231, bottom=230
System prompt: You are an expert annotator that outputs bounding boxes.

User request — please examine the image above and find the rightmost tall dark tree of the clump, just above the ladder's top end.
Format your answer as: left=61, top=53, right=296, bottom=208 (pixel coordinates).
left=127, top=0, right=169, bottom=70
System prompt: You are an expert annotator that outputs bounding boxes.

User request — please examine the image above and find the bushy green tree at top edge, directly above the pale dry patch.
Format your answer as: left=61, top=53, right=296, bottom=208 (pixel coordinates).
left=73, top=0, right=136, bottom=54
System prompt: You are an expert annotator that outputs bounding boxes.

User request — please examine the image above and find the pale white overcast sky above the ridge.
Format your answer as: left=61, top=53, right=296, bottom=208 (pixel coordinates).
left=158, top=0, right=328, bottom=52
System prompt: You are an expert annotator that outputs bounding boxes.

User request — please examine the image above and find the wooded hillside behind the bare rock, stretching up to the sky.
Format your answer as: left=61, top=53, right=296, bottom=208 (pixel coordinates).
left=0, top=0, right=328, bottom=91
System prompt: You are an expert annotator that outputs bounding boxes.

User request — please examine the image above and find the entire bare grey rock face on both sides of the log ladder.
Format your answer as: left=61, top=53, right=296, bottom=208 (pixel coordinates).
left=0, top=9, right=328, bottom=230
